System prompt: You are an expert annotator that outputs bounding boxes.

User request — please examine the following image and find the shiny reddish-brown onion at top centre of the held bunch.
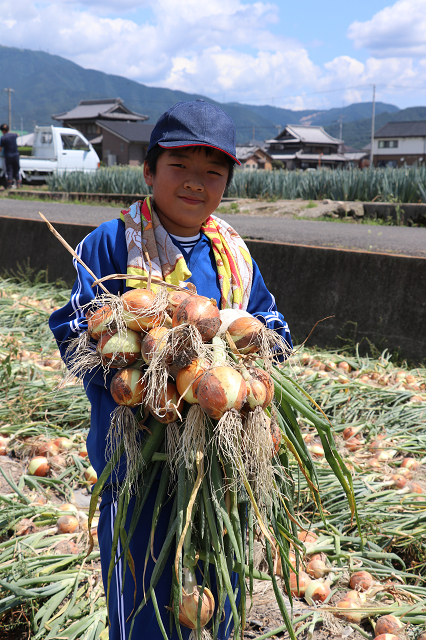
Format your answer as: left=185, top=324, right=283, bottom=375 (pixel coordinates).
left=172, top=296, right=220, bottom=342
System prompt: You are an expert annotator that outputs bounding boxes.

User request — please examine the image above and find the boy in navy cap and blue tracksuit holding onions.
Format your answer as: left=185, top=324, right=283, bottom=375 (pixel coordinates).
left=50, top=100, right=291, bottom=640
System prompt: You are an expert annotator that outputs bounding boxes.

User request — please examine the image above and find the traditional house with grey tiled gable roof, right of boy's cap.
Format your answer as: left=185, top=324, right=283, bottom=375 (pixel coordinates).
left=265, top=124, right=346, bottom=169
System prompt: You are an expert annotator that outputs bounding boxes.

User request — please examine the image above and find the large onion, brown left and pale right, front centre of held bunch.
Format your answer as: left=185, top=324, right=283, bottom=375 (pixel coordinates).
left=195, top=366, right=247, bottom=420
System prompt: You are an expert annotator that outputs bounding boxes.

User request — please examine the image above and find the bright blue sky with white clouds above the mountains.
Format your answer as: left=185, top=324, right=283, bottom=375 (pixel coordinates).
left=0, top=0, right=426, bottom=109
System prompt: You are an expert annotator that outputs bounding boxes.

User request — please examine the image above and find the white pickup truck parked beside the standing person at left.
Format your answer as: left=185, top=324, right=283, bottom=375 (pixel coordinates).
left=0, top=126, right=99, bottom=183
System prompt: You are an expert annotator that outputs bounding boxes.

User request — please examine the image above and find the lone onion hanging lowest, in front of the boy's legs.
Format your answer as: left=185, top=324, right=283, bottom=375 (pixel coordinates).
left=179, top=567, right=215, bottom=629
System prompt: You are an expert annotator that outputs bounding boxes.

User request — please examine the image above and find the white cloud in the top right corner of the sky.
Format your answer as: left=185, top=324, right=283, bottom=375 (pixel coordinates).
left=348, top=0, right=426, bottom=57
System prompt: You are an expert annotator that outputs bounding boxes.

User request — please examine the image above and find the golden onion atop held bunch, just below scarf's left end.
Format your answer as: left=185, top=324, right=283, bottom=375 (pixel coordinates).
left=121, top=289, right=167, bottom=331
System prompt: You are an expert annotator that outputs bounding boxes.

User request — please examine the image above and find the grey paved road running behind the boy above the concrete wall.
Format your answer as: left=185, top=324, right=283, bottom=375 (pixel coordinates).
left=0, top=198, right=426, bottom=258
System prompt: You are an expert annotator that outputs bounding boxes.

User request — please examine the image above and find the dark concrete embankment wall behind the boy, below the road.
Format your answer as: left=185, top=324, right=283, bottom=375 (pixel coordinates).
left=0, top=217, right=426, bottom=361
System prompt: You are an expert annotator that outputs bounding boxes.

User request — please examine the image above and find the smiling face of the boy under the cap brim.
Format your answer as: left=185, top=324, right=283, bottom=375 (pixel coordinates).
left=144, top=146, right=229, bottom=237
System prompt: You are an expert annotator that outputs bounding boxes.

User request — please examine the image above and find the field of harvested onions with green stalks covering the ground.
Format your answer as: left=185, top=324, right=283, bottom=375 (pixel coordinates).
left=0, top=279, right=426, bottom=640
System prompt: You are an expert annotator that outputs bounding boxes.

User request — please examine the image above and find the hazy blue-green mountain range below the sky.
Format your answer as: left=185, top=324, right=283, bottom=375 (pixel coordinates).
left=0, top=46, right=426, bottom=148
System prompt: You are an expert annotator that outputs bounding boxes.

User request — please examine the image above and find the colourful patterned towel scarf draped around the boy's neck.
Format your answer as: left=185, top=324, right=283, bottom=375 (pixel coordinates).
left=120, top=197, right=253, bottom=309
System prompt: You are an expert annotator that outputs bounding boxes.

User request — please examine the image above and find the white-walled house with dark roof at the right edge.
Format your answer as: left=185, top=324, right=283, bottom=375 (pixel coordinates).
left=373, top=120, right=426, bottom=167
